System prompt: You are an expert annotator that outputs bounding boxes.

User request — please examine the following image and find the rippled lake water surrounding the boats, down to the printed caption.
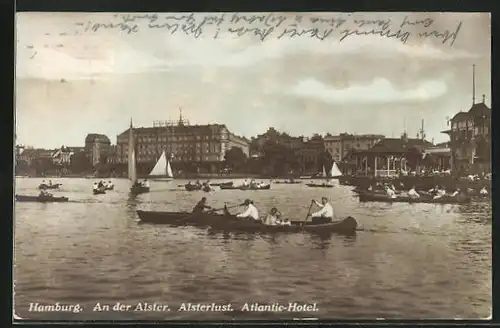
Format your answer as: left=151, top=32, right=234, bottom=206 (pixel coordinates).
left=14, top=178, right=492, bottom=320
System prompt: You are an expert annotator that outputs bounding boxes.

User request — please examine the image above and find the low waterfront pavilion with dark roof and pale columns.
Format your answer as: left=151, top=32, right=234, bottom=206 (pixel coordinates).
left=350, top=133, right=434, bottom=177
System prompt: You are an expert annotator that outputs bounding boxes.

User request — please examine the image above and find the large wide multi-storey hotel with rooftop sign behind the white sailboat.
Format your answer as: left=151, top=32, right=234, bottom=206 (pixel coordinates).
left=116, top=115, right=249, bottom=173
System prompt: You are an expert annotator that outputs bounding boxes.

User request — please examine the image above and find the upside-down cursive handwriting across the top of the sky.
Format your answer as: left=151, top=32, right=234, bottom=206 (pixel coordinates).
left=67, top=13, right=462, bottom=47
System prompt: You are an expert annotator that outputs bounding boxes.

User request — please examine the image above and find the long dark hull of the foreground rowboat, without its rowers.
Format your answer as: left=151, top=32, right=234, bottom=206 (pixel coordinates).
left=137, top=210, right=358, bottom=234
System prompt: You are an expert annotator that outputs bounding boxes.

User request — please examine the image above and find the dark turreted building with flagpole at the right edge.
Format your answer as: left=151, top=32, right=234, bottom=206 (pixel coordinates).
left=442, top=95, right=491, bottom=172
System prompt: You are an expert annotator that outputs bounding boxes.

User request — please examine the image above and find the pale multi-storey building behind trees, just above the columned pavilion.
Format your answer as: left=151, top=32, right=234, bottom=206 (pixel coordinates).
left=324, top=133, right=385, bottom=162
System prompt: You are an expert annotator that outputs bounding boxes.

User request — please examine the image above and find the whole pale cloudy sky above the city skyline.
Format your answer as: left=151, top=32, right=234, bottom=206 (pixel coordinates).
left=15, top=13, right=491, bottom=148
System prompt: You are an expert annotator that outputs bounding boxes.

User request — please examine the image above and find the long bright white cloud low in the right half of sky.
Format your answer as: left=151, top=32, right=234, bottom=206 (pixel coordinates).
left=285, top=78, right=448, bottom=104
